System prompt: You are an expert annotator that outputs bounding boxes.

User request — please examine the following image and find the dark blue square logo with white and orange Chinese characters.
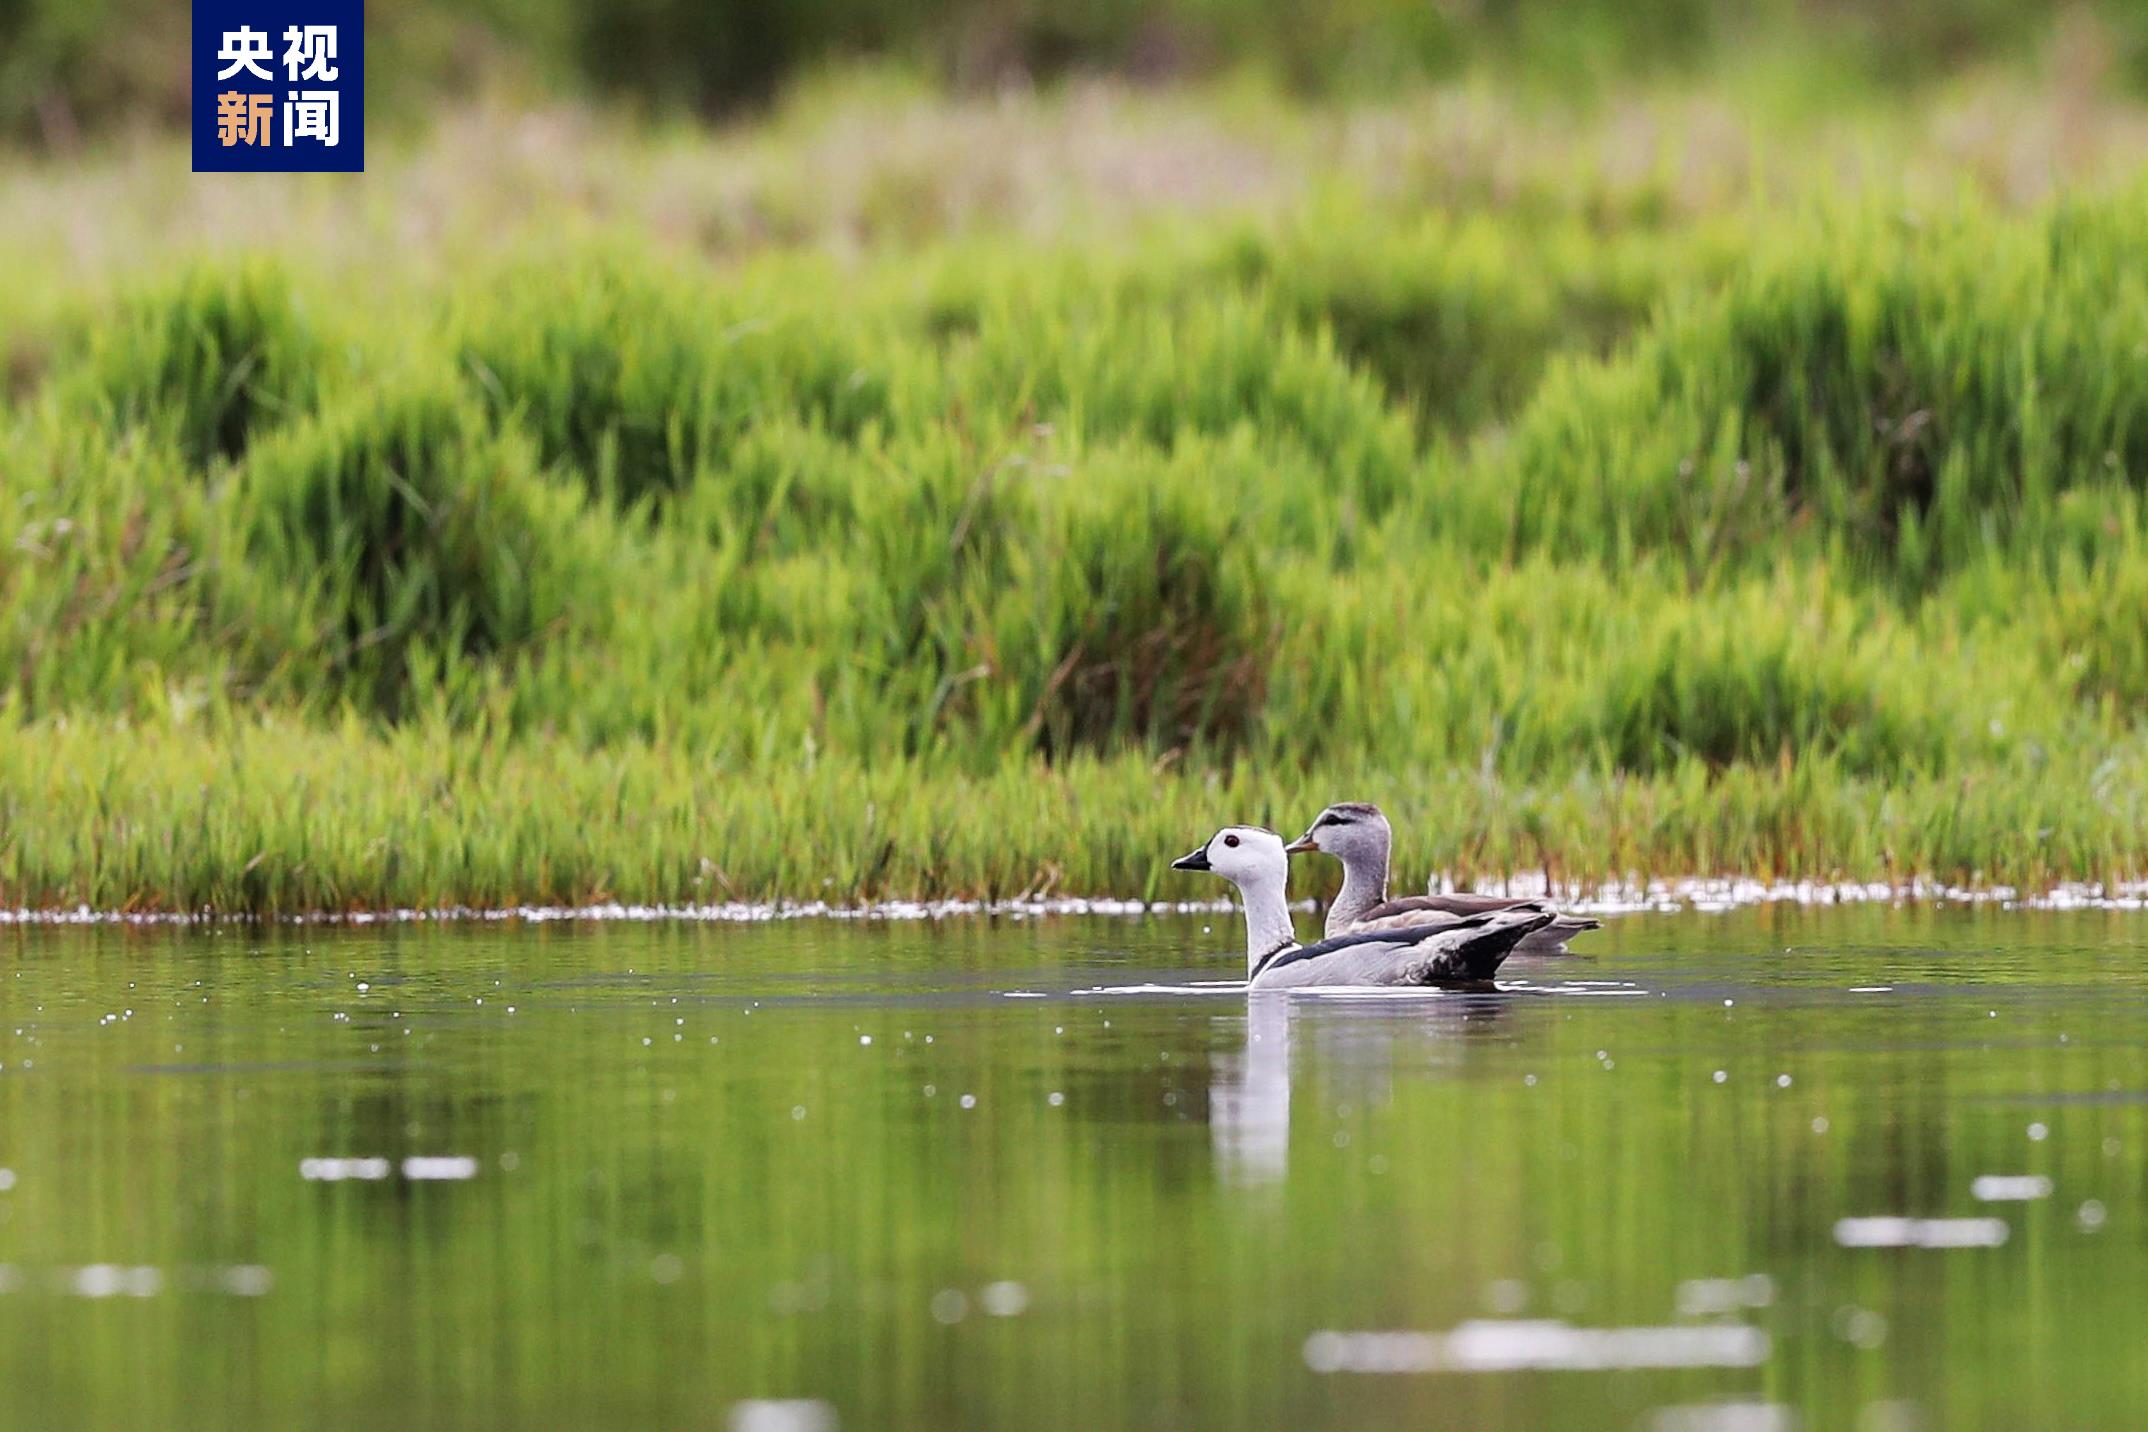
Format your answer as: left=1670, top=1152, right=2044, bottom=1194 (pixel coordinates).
left=193, top=0, right=365, bottom=174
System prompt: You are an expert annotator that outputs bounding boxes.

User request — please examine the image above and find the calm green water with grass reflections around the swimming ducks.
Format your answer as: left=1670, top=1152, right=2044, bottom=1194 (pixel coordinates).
left=0, top=906, right=2148, bottom=1432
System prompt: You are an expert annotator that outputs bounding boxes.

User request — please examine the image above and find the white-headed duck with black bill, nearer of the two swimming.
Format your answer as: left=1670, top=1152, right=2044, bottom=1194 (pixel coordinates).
left=1171, top=824, right=1555, bottom=990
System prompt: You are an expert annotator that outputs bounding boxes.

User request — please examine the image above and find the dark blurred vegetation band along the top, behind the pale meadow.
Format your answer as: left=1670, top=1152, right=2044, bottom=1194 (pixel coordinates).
left=0, top=0, right=2148, bottom=146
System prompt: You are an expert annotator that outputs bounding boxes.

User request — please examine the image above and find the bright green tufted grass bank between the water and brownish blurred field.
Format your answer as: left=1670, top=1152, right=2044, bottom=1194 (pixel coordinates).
left=12, top=75, right=2148, bottom=908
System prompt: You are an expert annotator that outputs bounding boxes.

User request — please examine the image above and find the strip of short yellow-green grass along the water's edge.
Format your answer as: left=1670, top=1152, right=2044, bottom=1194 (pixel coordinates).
left=0, top=721, right=2148, bottom=915
